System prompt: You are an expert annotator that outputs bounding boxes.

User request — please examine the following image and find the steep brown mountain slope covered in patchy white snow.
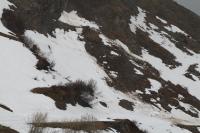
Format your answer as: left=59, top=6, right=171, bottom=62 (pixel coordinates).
left=0, top=0, right=200, bottom=133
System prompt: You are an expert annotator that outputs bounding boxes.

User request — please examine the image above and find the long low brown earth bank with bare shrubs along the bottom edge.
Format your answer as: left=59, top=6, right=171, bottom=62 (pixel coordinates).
left=29, top=113, right=145, bottom=133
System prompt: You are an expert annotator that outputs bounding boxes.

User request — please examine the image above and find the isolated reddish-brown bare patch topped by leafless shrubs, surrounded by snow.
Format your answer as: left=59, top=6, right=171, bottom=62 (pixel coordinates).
left=32, top=80, right=96, bottom=110
